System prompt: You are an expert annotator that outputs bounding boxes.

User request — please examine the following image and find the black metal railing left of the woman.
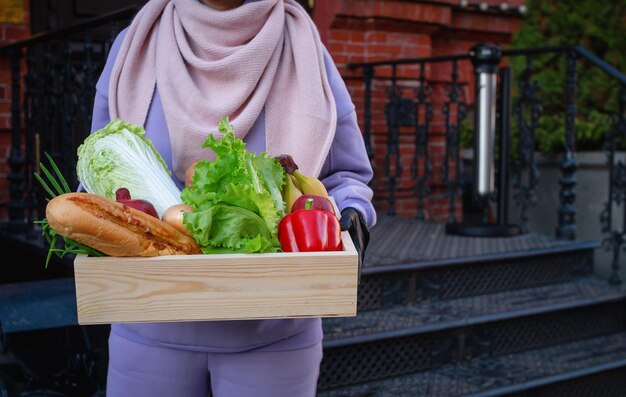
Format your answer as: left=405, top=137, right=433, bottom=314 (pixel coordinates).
left=0, top=7, right=137, bottom=234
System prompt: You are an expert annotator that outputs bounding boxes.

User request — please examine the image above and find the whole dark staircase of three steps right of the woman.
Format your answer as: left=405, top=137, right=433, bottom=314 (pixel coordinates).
left=318, top=216, right=626, bottom=397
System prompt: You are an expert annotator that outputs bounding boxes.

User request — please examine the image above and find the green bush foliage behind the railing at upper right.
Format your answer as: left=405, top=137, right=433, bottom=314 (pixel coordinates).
left=511, top=0, right=626, bottom=153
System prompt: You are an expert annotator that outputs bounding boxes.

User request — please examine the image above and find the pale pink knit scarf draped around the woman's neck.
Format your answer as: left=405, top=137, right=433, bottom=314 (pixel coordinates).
left=109, top=0, right=337, bottom=180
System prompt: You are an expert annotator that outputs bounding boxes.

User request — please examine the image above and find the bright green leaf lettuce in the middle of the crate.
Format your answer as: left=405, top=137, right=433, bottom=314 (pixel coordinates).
left=181, top=118, right=285, bottom=253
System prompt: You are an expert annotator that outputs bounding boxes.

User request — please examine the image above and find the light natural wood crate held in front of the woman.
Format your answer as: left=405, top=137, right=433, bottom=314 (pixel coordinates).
left=74, top=226, right=358, bottom=324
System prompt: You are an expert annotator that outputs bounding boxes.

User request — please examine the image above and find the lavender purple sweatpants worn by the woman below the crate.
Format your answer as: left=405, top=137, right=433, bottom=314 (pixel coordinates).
left=106, top=332, right=322, bottom=397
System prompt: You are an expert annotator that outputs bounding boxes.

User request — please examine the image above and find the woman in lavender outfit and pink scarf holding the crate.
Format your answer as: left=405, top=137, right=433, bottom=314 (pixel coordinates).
left=92, top=0, right=376, bottom=397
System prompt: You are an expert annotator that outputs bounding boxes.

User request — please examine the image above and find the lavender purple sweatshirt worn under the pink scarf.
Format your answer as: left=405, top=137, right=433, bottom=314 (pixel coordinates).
left=92, top=21, right=376, bottom=353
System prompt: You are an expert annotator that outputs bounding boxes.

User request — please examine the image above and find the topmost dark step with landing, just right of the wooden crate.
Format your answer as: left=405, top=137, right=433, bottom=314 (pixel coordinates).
left=358, top=217, right=599, bottom=311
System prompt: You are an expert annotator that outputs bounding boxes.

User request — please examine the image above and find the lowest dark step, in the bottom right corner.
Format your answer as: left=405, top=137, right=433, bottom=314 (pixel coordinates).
left=317, top=332, right=626, bottom=397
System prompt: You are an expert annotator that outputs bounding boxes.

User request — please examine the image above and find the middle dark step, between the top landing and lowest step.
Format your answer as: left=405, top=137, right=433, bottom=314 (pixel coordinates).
left=319, top=277, right=626, bottom=390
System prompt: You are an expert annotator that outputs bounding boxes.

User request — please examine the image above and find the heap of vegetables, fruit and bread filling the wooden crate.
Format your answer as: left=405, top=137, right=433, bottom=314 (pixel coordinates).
left=37, top=118, right=352, bottom=262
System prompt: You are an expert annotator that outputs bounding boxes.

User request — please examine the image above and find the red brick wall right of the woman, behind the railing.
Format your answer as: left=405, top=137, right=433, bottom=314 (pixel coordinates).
left=313, top=0, right=523, bottom=221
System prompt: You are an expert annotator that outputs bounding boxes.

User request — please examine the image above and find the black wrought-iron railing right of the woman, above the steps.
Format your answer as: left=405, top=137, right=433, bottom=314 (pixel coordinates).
left=348, top=46, right=626, bottom=284
